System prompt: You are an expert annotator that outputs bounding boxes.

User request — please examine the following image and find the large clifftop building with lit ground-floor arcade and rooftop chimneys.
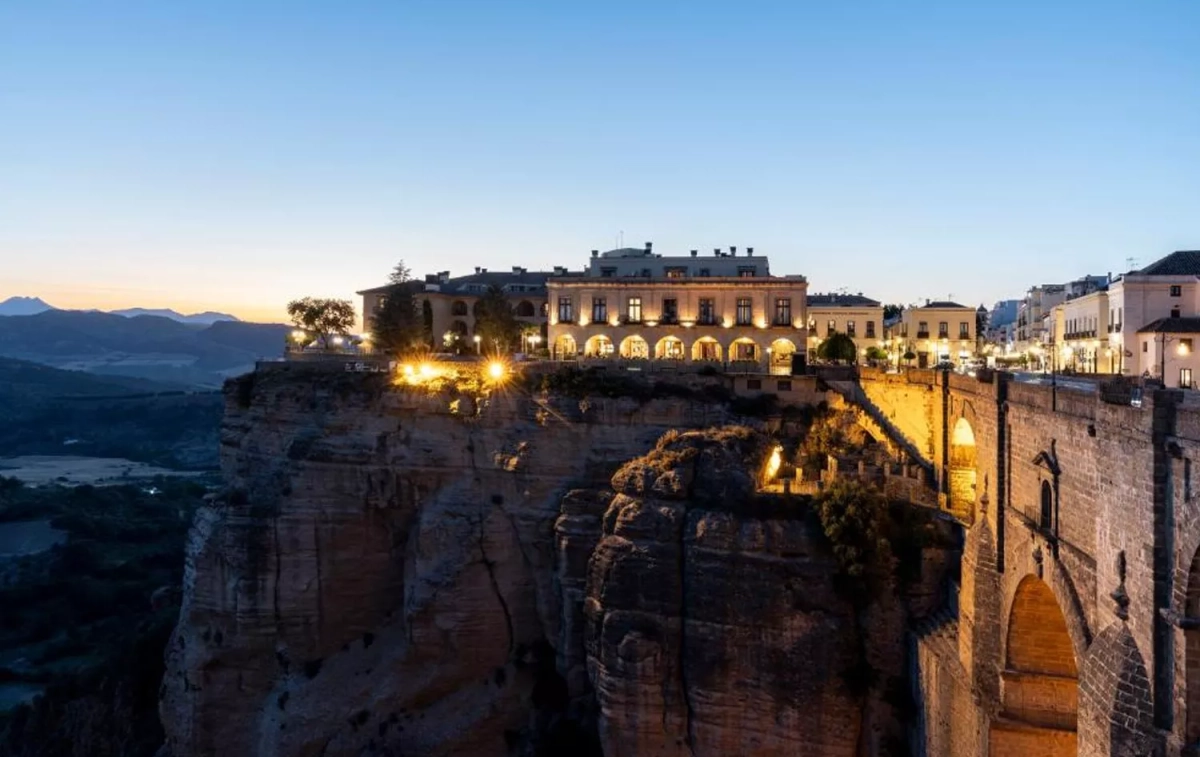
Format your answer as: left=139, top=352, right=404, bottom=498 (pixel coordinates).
left=546, top=242, right=809, bottom=373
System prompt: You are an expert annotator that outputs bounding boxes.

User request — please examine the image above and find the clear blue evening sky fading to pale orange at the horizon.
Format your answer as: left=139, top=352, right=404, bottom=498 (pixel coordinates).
left=0, top=0, right=1200, bottom=320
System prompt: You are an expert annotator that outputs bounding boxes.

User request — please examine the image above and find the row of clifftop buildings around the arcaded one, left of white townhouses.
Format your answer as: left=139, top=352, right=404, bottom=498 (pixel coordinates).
left=359, top=242, right=978, bottom=373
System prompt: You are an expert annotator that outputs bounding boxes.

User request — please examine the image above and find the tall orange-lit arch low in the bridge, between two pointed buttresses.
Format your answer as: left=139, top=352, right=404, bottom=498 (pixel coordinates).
left=990, top=576, right=1079, bottom=757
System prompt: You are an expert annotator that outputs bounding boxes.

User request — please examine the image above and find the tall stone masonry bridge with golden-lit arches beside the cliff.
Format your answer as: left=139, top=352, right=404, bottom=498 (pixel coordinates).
left=838, top=370, right=1200, bottom=757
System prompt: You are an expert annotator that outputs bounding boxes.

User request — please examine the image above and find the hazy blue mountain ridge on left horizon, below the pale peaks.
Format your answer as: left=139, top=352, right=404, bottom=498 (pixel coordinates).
left=0, top=309, right=290, bottom=387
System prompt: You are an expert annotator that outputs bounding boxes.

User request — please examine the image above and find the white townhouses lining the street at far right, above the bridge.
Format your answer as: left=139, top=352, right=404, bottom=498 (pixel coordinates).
left=988, top=250, right=1200, bottom=387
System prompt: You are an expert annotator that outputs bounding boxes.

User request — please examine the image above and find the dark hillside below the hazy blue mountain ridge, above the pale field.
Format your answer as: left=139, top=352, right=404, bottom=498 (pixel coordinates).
left=0, top=358, right=222, bottom=468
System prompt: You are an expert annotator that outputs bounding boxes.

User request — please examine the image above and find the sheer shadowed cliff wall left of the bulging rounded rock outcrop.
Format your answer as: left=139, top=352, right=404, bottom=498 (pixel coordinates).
left=161, top=368, right=727, bottom=757
